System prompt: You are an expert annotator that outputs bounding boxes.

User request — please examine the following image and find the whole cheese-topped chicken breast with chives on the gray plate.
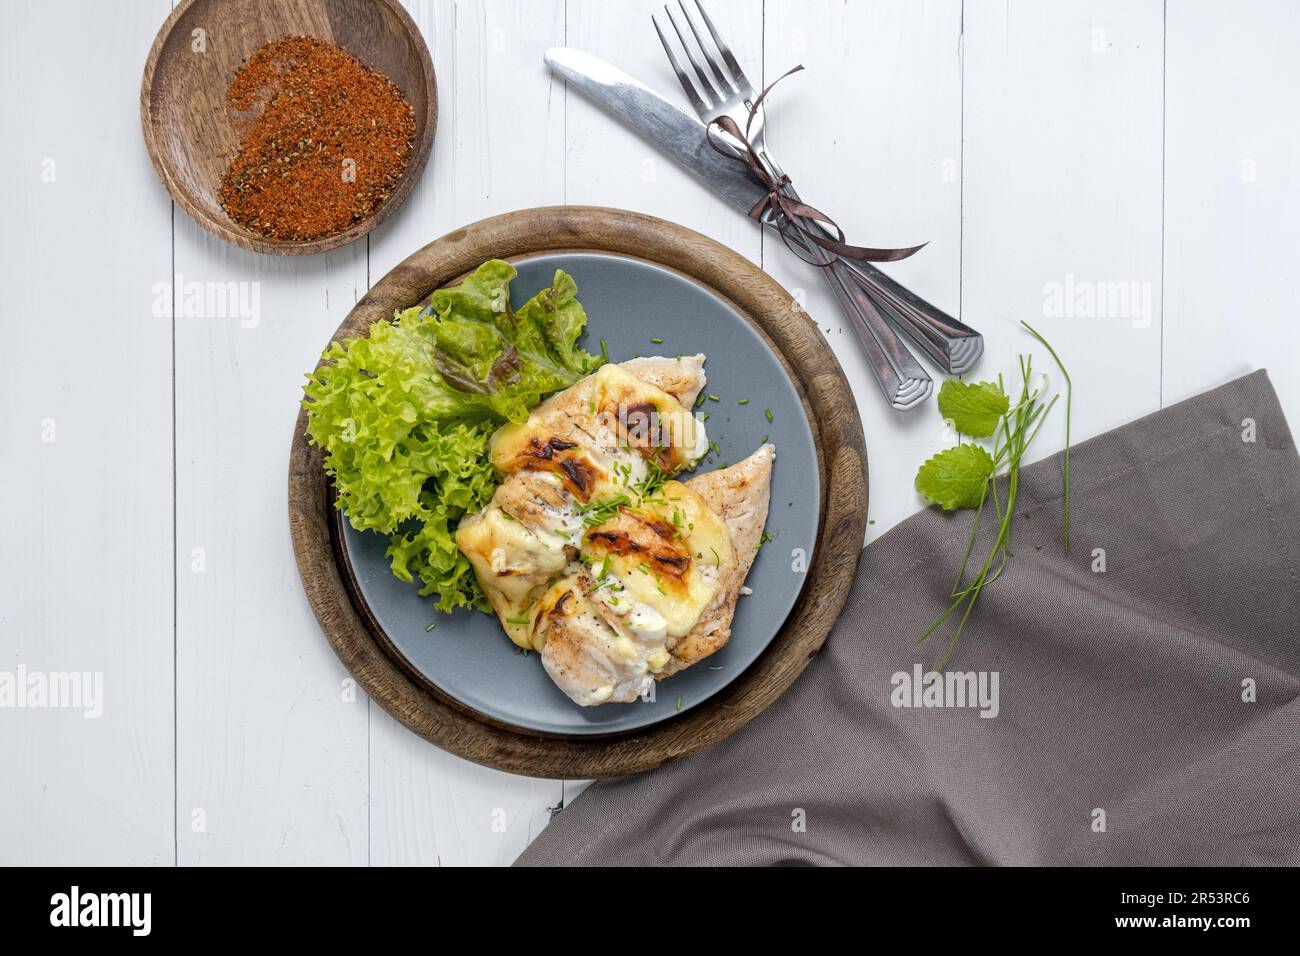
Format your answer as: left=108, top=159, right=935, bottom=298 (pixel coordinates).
left=456, top=355, right=774, bottom=706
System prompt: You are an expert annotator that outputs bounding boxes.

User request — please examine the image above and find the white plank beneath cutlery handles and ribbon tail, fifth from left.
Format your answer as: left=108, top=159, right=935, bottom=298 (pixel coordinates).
left=764, top=0, right=967, bottom=540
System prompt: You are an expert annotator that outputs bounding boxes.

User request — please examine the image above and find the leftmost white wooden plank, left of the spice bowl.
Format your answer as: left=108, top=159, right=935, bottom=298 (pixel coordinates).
left=0, top=0, right=174, bottom=866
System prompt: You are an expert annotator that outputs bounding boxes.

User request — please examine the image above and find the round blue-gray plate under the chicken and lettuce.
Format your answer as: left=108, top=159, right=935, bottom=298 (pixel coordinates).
left=343, top=254, right=820, bottom=735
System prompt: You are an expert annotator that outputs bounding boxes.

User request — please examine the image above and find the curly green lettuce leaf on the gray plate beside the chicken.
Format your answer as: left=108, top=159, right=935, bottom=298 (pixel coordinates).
left=303, top=259, right=601, bottom=611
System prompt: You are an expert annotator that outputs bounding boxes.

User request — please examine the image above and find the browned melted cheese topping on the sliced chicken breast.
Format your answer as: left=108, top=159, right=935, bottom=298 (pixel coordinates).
left=456, top=364, right=732, bottom=658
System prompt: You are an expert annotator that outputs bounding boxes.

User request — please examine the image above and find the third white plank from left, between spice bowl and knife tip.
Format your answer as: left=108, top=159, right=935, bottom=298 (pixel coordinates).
left=369, top=0, right=564, bottom=865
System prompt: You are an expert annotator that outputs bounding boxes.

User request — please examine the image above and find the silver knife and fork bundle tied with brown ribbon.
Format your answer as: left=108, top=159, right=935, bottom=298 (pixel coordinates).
left=546, top=0, right=984, bottom=411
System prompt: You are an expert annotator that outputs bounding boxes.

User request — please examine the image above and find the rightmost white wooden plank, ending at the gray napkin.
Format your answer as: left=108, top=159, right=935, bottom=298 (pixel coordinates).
left=1162, top=0, right=1300, bottom=411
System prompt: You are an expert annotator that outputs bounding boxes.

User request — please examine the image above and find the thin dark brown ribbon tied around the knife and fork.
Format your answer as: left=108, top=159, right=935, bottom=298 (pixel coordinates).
left=707, top=64, right=927, bottom=268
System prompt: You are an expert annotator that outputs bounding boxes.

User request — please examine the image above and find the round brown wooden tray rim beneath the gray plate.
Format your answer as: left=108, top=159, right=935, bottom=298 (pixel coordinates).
left=289, top=206, right=867, bottom=779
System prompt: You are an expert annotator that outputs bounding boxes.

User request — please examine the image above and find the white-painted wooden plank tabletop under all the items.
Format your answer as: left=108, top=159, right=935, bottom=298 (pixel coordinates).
left=0, top=0, right=1300, bottom=865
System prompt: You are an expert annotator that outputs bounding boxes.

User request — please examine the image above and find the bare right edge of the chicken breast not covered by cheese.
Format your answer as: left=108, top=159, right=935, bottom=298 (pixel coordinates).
left=655, top=445, right=776, bottom=678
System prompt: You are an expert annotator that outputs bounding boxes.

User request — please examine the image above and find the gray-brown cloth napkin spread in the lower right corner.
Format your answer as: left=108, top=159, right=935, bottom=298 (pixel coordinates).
left=519, top=371, right=1300, bottom=865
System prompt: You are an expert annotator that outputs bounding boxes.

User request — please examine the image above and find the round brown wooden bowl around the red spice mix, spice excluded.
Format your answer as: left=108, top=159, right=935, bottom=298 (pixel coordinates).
left=140, top=0, right=438, bottom=255
